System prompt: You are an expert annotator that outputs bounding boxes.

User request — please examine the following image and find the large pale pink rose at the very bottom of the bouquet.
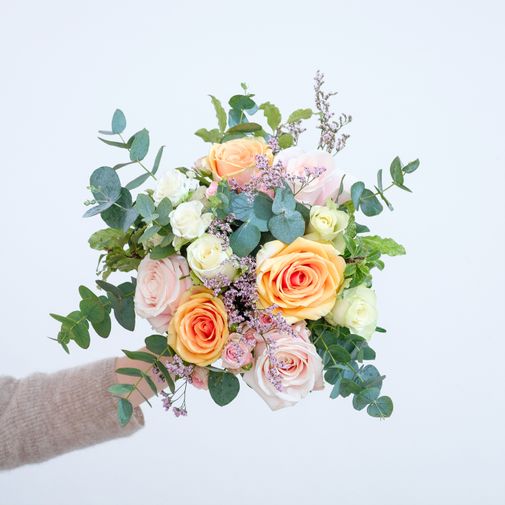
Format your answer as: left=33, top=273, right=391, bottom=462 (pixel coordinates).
left=244, top=323, right=323, bottom=410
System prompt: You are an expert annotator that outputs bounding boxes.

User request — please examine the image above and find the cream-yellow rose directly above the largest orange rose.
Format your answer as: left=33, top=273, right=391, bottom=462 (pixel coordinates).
left=306, top=205, right=349, bottom=254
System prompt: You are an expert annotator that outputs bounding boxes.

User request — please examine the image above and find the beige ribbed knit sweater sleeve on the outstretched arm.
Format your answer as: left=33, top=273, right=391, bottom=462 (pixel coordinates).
left=0, top=359, right=144, bottom=470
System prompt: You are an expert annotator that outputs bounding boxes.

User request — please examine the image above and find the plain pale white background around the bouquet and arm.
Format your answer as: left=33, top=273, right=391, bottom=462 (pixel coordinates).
left=0, top=0, right=505, bottom=505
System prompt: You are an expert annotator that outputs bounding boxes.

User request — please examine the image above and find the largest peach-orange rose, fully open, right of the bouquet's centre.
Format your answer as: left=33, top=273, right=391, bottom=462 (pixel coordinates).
left=256, top=237, right=345, bottom=323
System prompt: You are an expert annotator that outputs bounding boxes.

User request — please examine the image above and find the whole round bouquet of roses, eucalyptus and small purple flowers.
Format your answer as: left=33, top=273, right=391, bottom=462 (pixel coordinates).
left=51, top=72, right=419, bottom=425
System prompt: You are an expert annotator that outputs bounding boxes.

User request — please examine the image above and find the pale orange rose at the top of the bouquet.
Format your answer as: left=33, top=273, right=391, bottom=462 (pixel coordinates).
left=207, top=137, right=273, bottom=184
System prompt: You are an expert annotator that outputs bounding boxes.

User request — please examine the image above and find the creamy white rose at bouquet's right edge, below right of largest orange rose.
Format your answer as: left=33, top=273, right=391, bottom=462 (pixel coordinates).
left=325, top=285, right=377, bottom=340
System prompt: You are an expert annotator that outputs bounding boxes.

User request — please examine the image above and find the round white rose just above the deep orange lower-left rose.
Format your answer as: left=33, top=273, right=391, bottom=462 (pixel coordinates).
left=187, top=233, right=236, bottom=280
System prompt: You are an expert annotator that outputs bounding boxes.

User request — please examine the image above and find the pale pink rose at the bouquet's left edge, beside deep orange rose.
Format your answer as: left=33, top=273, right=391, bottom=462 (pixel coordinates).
left=135, top=255, right=192, bottom=333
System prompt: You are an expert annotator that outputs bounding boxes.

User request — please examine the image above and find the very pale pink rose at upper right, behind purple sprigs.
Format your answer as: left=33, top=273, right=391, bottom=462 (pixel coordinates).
left=274, top=147, right=355, bottom=205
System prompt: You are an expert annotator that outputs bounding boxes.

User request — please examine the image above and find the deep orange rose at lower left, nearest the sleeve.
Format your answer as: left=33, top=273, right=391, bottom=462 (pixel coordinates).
left=168, top=287, right=228, bottom=366
